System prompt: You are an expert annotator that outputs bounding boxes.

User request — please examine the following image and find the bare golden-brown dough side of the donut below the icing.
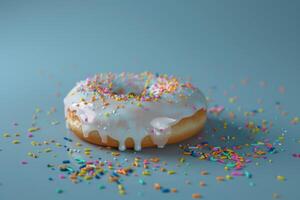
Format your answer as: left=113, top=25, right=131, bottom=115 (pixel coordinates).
left=66, top=109, right=207, bottom=148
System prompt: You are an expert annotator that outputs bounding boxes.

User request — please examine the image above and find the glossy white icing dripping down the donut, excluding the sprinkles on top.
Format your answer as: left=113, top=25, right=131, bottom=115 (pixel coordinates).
left=64, top=74, right=207, bottom=151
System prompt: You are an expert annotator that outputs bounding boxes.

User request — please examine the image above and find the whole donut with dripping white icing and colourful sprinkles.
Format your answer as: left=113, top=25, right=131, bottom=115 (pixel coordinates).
left=64, top=72, right=207, bottom=151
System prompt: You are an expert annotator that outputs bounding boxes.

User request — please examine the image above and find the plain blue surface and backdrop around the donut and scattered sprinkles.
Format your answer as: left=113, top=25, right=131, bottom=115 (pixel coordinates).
left=0, top=0, right=300, bottom=200
